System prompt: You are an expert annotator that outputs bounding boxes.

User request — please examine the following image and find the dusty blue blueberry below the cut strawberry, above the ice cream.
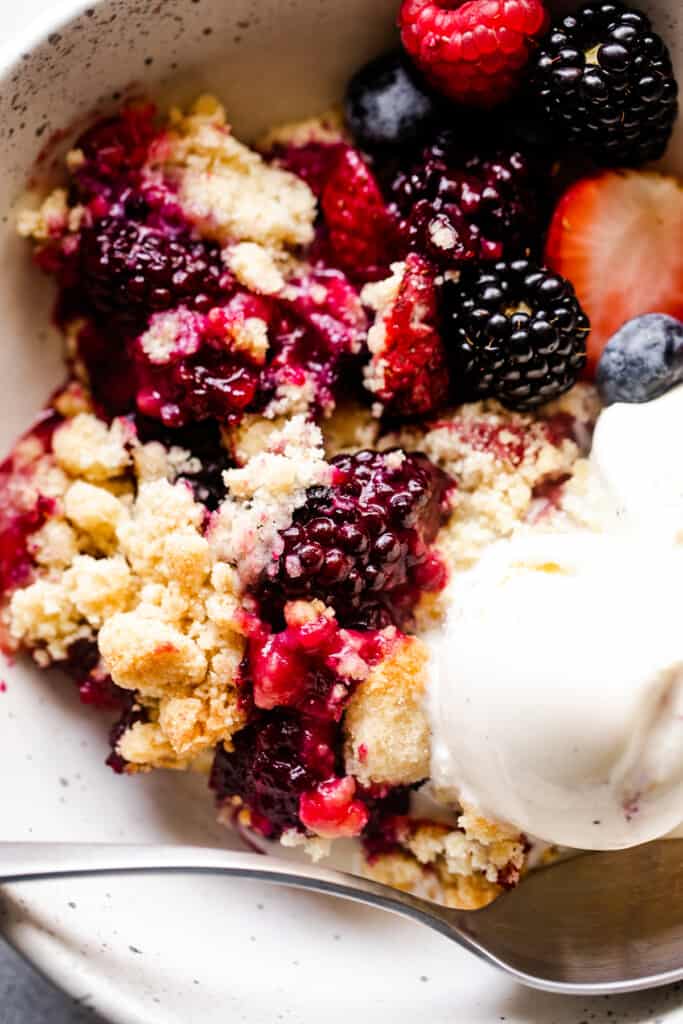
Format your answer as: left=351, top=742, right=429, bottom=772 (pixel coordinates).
left=596, top=313, right=683, bottom=406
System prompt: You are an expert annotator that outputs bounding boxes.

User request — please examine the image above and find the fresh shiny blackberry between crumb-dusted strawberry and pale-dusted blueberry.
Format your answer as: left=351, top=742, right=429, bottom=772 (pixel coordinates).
left=443, top=259, right=590, bottom=410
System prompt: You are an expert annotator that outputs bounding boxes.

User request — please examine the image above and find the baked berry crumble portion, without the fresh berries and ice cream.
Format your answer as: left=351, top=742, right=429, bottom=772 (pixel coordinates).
left=0, top=83, right=597, bottom=908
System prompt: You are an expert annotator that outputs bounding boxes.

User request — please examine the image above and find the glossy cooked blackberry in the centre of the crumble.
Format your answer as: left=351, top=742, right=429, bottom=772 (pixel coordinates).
left=260, top=451, right=451, bottom=629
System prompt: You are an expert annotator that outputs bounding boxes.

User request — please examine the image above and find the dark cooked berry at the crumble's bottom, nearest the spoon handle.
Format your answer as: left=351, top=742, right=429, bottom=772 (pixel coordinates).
left=211, top=710, right=338, bottom=839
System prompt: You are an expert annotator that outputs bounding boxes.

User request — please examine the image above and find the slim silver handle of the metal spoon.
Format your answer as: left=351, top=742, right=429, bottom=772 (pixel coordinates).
left=0, top=842, right=464, bottom=937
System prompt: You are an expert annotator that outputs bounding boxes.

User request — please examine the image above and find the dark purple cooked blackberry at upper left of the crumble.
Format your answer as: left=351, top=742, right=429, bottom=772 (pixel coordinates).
left=80, top=217, right=229, bottom=323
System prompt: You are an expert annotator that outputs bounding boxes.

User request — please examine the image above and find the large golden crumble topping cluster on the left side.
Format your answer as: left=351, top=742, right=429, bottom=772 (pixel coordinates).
left=8, top=414, right=245, bottom=766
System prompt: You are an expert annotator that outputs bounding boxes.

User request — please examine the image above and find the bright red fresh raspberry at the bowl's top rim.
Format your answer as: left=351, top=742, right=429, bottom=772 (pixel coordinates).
left=398, top=0, right=548, bottom=106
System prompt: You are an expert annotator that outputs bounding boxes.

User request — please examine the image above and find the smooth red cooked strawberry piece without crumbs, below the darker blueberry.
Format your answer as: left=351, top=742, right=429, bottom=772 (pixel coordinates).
left=322, top=147, right=393, bottom=281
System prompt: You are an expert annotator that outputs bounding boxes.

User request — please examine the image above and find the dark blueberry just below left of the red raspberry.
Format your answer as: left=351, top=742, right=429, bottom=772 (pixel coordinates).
left=345, top=52, right=435, bottom=150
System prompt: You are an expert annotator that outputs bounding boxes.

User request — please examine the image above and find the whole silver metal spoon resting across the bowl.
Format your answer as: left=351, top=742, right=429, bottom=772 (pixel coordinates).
left=0, top=840, right=683, bottom=995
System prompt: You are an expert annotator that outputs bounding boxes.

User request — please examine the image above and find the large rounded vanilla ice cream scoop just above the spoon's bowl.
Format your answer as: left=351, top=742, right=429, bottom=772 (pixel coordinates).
left=430, top=531, right=683, bottom=850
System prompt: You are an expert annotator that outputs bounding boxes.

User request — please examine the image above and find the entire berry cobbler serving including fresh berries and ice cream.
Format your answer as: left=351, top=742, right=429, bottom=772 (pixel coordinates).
left=0, top=0, right=683, bottom=908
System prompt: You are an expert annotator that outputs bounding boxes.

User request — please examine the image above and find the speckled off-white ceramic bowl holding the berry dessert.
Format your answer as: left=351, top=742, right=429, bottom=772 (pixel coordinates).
left=0, top=0, right=683, bottom=1024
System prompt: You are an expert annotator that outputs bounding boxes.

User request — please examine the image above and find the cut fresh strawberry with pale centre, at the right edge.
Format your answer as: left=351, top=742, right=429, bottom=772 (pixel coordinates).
left=546, top=171, right=683, bottom=376
